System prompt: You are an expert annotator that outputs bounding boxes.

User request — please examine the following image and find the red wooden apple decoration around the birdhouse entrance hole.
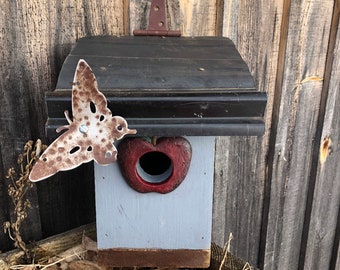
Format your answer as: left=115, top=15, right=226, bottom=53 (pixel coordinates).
left=118, top=137, right=192, bottom=194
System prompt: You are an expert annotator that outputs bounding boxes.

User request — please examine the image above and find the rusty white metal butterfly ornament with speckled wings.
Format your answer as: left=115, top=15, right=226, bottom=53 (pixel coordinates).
left=29, top=59, right=137, bottom=182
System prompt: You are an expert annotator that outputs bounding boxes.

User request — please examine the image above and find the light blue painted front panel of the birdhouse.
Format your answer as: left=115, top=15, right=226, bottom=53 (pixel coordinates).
left=95, top=136, right=215, bottom=249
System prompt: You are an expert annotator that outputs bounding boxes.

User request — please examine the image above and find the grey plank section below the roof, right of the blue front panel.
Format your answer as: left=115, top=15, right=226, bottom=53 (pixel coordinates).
left=213, top=137, right=263, bottom=264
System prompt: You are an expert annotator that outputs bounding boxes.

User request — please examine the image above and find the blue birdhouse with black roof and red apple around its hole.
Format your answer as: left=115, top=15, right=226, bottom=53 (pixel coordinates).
left=41, top=36, right=266, bottom=268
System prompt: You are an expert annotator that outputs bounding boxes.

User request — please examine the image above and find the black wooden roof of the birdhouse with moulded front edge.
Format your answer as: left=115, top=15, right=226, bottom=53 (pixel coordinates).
left=46, top=36, right=266, bottom=137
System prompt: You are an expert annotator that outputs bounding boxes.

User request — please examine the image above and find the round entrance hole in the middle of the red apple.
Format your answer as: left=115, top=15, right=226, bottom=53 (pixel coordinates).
left=137, top=152, right=173, bottom=184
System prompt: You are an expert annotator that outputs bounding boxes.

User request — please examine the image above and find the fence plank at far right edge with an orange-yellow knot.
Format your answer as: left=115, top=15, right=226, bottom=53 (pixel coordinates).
left=305, top=1, right=340, bottom=269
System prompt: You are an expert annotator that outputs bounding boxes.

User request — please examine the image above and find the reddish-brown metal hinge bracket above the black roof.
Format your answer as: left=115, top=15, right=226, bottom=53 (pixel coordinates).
left=133, top=0, right=181, bottom=37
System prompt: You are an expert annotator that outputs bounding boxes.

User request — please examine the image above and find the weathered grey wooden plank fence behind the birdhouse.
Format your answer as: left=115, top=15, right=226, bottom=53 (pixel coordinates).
left=0, top=0, right=340, bottom=269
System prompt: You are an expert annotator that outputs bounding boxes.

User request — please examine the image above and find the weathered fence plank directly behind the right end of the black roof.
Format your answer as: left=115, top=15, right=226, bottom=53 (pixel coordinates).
left=213, top=1, right=283, bottom=265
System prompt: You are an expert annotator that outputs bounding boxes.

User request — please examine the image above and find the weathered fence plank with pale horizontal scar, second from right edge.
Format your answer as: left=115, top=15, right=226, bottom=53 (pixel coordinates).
left=264, top=1, right=333, bottom=269
